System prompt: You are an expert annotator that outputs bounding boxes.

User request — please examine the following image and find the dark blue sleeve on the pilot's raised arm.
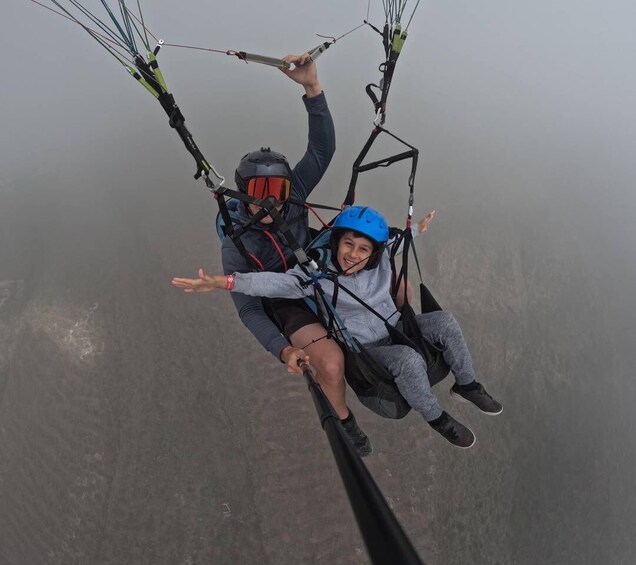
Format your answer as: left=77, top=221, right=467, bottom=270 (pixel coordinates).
left=292, top=92, right=336, bottom=201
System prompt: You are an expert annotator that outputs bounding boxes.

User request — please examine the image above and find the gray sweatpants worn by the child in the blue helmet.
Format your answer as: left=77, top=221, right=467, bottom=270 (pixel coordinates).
left=366, top=311, right=475, bottom=422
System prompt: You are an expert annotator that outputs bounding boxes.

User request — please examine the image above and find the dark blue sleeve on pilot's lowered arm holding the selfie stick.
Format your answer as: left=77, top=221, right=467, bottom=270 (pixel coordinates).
left=221, top=238, right=289, bottom=360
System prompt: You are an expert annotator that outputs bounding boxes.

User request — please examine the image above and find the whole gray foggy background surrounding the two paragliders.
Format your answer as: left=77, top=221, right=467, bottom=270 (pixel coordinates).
left=0, top=0, right=636, bottom=565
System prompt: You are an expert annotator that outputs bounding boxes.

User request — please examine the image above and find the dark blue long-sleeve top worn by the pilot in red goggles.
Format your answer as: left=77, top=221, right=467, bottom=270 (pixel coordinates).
left=221, top=93, right=336, bottom=359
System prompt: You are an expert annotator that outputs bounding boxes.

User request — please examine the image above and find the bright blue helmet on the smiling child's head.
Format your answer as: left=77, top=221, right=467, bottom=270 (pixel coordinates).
left=330, top=206, right=389, bottom=270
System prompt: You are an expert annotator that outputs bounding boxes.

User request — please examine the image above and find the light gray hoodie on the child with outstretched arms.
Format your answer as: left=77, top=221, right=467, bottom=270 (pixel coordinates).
left=232, top=251, right=400, bottom=345
